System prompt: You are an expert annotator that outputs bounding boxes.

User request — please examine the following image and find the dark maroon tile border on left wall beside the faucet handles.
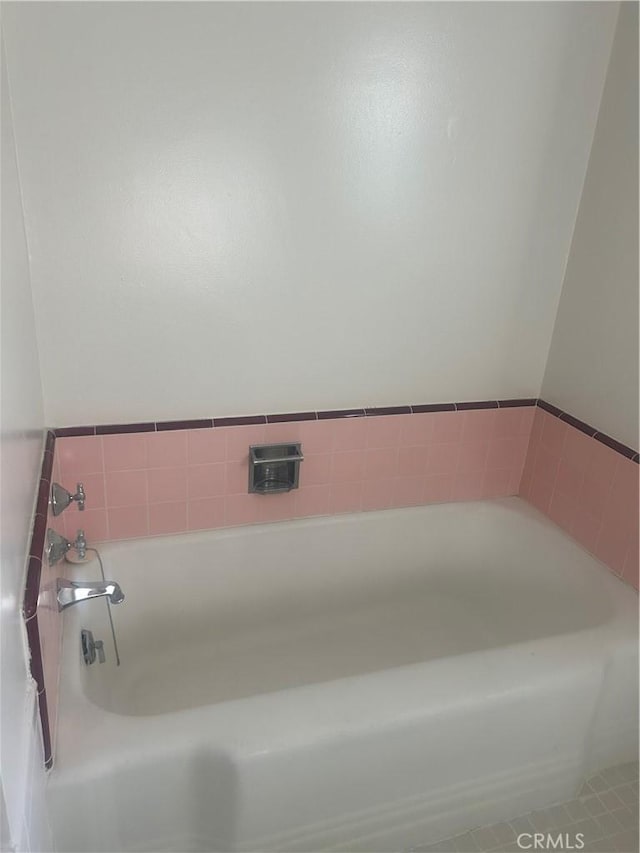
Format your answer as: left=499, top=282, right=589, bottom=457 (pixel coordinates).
left=22, top=427, right=57, bottom=769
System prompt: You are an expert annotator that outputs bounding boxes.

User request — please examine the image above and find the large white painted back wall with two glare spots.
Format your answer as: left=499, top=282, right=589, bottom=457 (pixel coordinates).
left=5, top=2, right=617, bottom=425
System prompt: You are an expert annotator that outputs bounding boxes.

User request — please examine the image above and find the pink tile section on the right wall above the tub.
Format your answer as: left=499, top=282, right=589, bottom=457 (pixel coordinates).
left=520, top=409, right=639, bottom=589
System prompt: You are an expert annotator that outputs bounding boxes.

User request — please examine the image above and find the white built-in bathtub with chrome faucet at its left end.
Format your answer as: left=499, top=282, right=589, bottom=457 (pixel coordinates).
left=49, top=497, right=638, bottom=853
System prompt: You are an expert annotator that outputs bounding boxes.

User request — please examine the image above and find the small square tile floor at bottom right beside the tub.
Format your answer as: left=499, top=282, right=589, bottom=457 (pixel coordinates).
left=414, top=762, right=638, bottom=853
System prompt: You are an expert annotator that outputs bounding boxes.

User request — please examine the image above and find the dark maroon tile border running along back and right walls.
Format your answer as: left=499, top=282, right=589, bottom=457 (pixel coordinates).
left=49, top=397, right=638, bottom=464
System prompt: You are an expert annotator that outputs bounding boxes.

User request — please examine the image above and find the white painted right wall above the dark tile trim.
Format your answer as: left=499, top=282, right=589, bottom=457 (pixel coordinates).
left=542, top=3, right=638, bottom=449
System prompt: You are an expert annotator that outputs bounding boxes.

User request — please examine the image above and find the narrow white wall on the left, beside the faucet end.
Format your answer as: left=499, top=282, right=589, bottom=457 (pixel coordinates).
left=0, top=36, right=53, bottom=851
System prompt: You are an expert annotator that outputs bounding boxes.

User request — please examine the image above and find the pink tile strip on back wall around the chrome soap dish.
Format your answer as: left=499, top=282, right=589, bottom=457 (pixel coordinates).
left=56, top=407, right=535, bottom=542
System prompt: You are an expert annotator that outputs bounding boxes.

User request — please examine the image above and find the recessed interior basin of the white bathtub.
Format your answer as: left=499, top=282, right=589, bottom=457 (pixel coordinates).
left=76, top=496, right=611, bottom=715
